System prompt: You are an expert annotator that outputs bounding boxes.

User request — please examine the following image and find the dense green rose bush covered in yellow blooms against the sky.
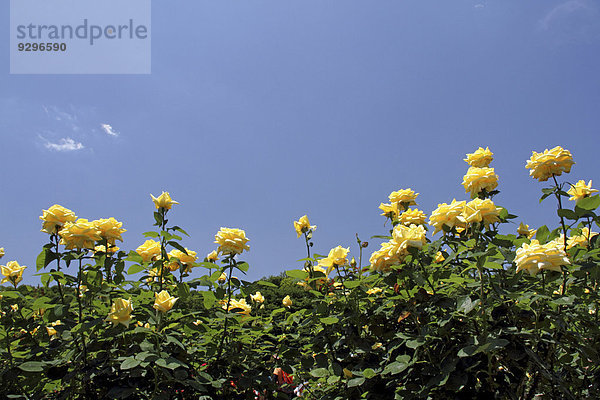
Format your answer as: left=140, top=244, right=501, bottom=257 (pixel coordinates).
left=0, top=147, right=600, bottom=399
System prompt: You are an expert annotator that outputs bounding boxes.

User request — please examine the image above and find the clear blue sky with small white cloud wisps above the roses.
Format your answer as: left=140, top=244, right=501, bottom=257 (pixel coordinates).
left=0, top=0, right=600, bottom=283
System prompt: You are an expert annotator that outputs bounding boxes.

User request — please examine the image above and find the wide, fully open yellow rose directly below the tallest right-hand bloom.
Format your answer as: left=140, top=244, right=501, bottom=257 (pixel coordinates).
left=515, top=239, right=570, bottom=275
